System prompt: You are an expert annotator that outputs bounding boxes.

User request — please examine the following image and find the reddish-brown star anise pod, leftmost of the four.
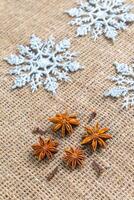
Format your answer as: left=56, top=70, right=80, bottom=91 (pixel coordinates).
left=32, top=137, right=58, bottom=160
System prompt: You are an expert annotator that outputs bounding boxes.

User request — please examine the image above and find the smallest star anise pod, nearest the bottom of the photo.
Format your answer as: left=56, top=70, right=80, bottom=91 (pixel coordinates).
left=63, top=147, right=85, bottom=169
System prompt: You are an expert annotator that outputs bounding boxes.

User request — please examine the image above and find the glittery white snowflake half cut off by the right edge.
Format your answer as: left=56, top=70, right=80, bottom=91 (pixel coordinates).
left=104, top=63, right=134, bottom=108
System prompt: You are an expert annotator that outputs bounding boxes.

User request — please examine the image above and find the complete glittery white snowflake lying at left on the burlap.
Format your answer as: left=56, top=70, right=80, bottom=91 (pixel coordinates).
left=5, top=35, right=82, bottom=94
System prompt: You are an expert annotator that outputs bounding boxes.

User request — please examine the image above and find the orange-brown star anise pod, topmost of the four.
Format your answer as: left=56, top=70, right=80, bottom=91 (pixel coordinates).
left=49, top=112, right=80, bottom=137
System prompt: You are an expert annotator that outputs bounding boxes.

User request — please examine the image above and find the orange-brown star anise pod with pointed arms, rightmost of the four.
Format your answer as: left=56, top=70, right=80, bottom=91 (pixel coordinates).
left=81, top=123, right=112, bottom=151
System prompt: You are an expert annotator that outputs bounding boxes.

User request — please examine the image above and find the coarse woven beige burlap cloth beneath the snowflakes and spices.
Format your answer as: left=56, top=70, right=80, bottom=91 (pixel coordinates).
left=0, top=0, right=134, bottom=200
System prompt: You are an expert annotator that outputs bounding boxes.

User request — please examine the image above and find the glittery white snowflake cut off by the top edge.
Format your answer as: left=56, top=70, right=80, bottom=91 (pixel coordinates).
left=66, top=0, right=134, bottom=40
